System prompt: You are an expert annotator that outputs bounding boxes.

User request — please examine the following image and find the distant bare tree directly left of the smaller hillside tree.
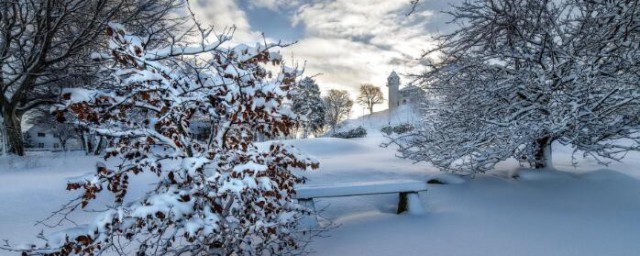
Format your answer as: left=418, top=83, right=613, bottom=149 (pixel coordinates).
left=322, top=89, right=353, bottom=131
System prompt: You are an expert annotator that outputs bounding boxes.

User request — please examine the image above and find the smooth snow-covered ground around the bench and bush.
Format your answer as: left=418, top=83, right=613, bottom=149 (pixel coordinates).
left=0, top=127, right=640, bottom=256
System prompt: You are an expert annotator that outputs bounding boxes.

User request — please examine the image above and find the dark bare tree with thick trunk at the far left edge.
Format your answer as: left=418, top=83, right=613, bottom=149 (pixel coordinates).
left=0, top=0, right=180, bottom=155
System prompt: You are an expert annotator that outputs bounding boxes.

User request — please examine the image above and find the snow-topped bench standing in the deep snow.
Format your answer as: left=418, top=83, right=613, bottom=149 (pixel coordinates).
left=294, top=180, right=427, bottom=226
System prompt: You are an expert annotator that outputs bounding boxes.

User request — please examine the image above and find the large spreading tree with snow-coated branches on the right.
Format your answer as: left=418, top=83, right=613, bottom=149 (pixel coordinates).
left=395, top=0, right=640, bottom=174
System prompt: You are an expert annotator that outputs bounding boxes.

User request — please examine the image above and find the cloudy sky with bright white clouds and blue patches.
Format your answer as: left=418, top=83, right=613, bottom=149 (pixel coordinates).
left=190, top=0, right=458, bottom=116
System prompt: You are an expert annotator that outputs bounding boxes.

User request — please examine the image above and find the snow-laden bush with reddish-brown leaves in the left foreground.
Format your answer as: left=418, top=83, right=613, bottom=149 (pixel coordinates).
left=17, top=24, right=318, bottom=255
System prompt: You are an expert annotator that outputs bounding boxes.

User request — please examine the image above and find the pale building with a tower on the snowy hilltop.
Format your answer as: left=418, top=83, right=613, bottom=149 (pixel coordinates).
left=387, top=71, right=425, bottom=110
